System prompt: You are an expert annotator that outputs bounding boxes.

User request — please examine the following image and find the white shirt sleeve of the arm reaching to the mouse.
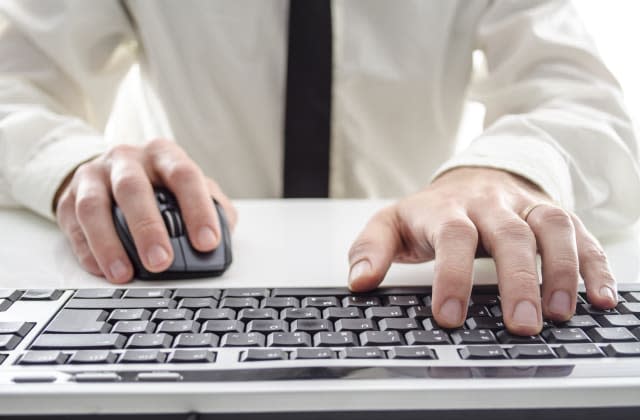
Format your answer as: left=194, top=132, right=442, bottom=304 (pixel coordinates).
left=0, top=0, right=136, bottom=219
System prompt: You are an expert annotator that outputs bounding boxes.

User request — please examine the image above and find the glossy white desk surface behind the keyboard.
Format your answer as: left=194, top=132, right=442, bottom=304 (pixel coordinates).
left=0, top=200, right=640, bottom=288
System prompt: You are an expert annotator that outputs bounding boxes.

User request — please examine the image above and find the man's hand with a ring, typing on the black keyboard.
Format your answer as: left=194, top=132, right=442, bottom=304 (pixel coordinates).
left=349, top=168, right=617, bottom=335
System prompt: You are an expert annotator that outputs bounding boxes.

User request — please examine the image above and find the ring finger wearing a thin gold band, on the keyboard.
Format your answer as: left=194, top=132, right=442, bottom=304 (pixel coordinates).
left=526, top=205, right=579, bottom=321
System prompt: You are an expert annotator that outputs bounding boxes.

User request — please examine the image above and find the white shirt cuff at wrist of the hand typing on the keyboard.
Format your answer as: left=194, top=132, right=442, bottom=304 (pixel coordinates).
left=432, top=135, right=574, bottom=210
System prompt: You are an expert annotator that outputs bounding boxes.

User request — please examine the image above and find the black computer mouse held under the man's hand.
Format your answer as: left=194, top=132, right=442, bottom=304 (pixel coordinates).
left=112, top=187, right=232, bottom=280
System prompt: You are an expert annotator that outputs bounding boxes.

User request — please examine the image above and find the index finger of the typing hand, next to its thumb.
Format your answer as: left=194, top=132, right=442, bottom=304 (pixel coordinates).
left=424, top=215, right=478, bottom=328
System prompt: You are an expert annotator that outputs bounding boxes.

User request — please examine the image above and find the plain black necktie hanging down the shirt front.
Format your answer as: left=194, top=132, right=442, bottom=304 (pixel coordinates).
left=284, top=0, right=332, bottom=198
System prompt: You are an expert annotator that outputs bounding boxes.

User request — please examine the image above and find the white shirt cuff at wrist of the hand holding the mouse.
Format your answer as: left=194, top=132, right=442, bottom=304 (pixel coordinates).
left=12, top=135, right=107, bottom=220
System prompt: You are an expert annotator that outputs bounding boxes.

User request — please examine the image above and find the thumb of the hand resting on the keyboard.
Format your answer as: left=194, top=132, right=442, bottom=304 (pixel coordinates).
left=349, top=207, right=400, bottom=292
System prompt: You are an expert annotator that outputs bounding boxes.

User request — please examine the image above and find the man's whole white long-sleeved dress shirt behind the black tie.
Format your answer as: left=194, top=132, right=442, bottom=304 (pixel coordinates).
left=0, top=0, right=640, bottom=233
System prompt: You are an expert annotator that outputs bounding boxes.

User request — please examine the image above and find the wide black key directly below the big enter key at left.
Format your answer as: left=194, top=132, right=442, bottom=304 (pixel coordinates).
left=31, top=334, right=127, bottom=350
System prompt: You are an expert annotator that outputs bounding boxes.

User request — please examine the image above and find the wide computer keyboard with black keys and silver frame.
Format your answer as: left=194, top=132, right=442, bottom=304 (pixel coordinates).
left=0, top=285, right=640, bottom=383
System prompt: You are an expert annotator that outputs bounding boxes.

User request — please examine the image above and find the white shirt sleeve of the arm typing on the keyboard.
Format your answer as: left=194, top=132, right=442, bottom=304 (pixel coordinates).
left=435, top=0, right=640, bottom=235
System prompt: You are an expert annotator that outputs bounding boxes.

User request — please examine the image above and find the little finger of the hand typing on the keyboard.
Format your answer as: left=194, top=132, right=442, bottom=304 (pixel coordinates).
left=571, top=215, right=618, bottom=308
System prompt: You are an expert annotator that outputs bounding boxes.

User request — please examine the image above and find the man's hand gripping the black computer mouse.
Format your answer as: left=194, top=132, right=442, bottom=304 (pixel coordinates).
left=56, top=140, right=236, bottom=283
